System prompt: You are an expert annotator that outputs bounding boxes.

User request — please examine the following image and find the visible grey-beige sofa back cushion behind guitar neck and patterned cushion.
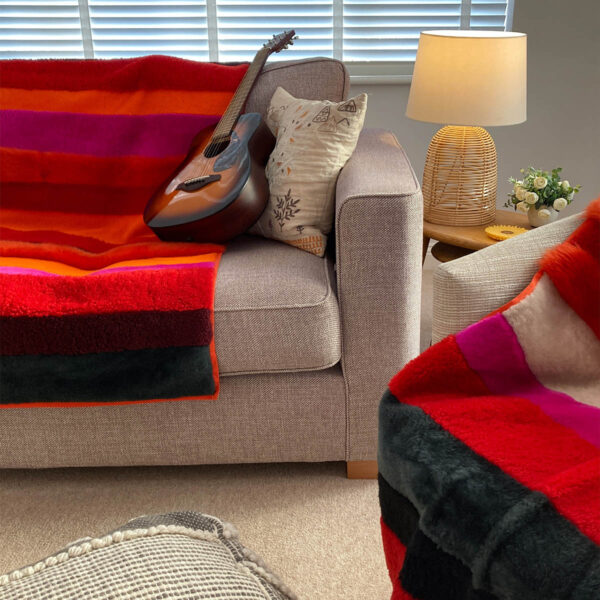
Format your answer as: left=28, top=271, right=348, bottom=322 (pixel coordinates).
left=245, top=57, right=350, bottom=118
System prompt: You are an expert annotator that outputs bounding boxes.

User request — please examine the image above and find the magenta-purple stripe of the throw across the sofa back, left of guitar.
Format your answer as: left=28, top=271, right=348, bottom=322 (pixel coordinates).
left=0, top=110, right=219, bottom=158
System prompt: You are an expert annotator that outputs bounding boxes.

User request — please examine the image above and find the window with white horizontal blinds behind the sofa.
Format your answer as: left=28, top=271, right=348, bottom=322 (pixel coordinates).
left=0, top=0, right=514, bottom=76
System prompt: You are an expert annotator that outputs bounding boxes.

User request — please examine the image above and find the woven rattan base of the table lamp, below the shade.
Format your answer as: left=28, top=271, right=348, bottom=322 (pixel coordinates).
left=423, top=125, right=498, bottom=225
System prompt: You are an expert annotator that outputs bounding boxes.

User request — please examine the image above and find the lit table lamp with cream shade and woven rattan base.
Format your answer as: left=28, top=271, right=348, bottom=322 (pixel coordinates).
left=406, top=30, right=527, bottom=225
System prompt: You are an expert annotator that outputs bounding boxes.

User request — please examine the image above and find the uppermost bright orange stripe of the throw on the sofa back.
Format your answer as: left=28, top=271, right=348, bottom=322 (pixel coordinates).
left=0, top=88, right=237, bottom=115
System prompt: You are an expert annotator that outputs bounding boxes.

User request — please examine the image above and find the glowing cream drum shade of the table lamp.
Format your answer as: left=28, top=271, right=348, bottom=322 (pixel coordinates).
left=406, top=30, right=527, bottom=127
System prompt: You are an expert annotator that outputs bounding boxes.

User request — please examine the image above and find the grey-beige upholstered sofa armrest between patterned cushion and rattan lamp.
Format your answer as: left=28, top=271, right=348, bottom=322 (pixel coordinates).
left=335, top=129, right=423, bottom=461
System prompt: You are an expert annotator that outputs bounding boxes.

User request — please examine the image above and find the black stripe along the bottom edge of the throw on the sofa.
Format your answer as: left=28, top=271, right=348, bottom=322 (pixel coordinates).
left=0, top=346, right=215, bottom=405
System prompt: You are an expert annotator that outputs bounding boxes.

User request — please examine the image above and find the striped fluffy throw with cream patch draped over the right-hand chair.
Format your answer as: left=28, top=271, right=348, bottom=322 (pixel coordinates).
left=379, top=199, right=600, bottom=600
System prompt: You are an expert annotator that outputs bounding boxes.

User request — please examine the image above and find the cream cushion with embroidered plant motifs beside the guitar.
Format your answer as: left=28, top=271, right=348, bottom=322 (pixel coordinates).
left=250, top=87, right=367, bottom=256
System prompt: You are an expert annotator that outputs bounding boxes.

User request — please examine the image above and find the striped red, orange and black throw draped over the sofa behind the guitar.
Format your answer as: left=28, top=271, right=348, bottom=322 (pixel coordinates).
left=0, top=56, right=247, bottom=407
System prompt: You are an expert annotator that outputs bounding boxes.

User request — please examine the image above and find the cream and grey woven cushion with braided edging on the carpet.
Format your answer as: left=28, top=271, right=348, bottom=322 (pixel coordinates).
left=0, top=512, right=294, bottom=600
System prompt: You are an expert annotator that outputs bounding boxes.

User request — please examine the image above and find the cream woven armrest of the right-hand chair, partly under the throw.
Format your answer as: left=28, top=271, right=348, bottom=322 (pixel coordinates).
left=432, top=215, right=582, bottom=344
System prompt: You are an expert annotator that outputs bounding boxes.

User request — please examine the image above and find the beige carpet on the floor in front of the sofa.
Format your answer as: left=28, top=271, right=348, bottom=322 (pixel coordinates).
left=0, top=463, right=391, bottom=600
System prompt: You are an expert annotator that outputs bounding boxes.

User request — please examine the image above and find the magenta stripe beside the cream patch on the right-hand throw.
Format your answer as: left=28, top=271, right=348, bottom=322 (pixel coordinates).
left=456, top=314, right=600, bottom=447
